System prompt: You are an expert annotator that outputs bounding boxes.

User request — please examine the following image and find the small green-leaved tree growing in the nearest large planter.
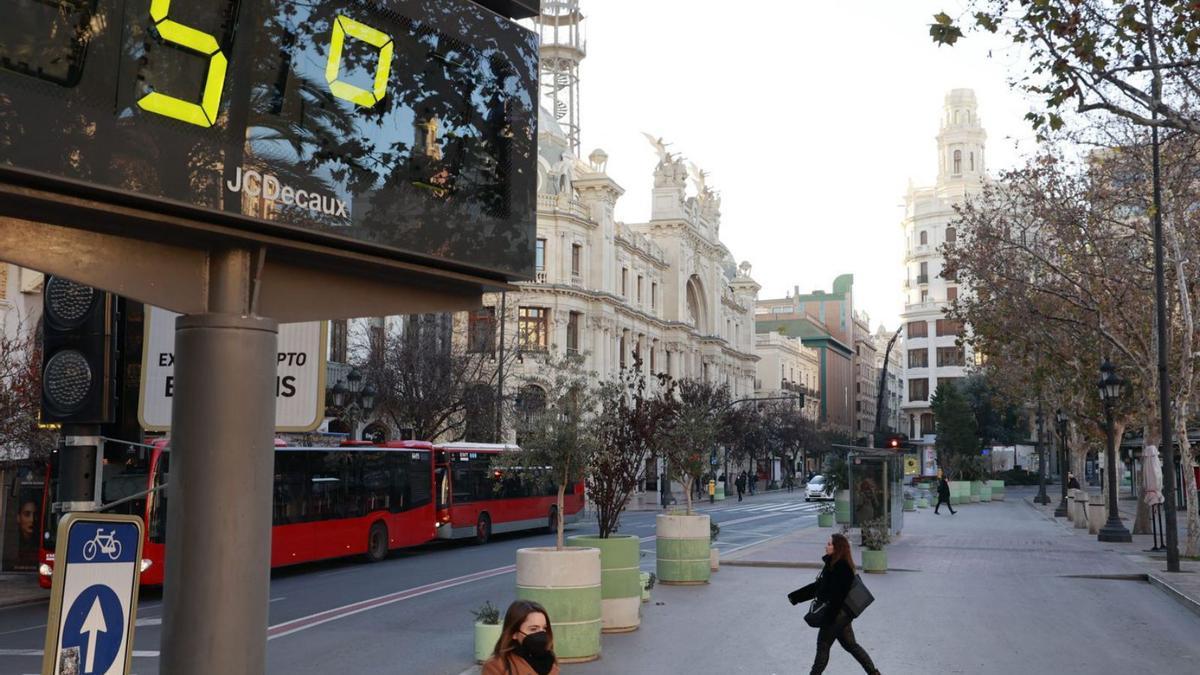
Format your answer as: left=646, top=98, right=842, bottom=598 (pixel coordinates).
left=492, top=354, right=598, bottom=550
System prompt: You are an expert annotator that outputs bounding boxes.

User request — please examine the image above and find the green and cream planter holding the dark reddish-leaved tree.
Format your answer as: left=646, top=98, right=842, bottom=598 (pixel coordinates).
left=566, top=534, right=642, bottom=633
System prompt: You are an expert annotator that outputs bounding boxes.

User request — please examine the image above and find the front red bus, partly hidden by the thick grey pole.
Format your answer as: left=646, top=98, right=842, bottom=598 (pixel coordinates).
left=38, top=441, right=436, bottom=587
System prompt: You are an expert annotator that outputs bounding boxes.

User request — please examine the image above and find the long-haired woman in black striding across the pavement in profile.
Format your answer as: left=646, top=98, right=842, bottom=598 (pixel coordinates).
left=787, top=534, right=880, bottom=675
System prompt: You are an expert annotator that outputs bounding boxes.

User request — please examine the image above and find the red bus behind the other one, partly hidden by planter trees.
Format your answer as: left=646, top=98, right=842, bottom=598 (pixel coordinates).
left=434, top=443, right=583, bottom=544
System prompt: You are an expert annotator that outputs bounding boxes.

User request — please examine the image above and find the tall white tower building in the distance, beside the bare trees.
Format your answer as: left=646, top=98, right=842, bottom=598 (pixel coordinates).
left=901, top=89, right=988, bottom=458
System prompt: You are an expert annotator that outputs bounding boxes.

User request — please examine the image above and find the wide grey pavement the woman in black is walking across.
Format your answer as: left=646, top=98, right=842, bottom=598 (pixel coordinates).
left=467, top=489, right=1200, bottom=675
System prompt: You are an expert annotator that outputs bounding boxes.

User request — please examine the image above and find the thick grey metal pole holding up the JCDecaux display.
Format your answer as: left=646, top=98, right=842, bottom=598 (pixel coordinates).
left=158, top=251, right=278, bottom=675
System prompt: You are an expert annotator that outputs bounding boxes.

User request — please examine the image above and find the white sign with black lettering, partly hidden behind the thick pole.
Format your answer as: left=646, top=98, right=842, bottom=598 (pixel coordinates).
left=138, top=306, right=328, bottom=431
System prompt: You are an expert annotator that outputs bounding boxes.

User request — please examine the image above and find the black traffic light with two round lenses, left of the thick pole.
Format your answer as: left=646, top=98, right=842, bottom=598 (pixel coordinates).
left=42, top=276, right=118, bottom=424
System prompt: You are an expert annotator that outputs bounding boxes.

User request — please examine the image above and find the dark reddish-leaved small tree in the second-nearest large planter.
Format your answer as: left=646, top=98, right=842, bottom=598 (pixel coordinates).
left=587, top=354, right=676, bottom=538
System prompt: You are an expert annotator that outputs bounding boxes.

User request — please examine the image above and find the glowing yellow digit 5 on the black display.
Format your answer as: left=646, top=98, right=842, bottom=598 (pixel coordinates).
left=138, top=0, right=229, bottom=127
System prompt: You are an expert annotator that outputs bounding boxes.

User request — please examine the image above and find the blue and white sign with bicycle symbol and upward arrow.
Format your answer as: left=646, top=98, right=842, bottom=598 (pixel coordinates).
left=42, top=513, right=142, bottom=675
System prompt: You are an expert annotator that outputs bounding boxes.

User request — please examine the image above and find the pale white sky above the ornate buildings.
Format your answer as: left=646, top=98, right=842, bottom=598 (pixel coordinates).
left=566, top=0, right=1033, bottom=329
